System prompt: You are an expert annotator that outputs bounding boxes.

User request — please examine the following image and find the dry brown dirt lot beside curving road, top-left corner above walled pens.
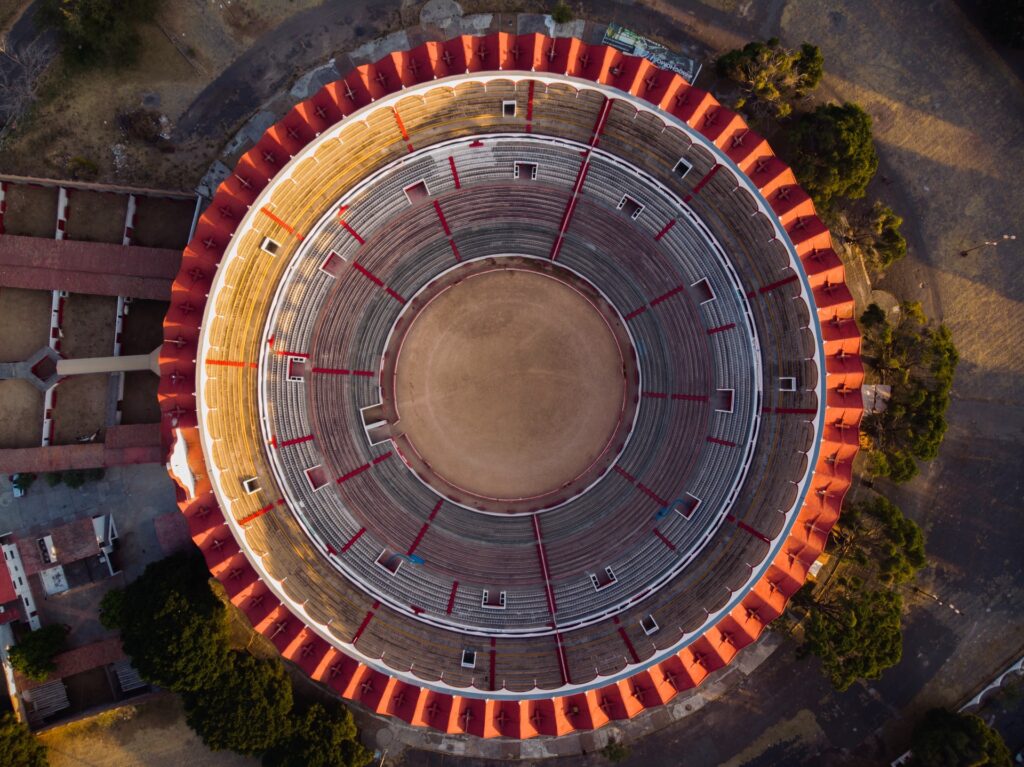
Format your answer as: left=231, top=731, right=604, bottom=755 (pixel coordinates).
left=0, top=0, right=318, bottom=189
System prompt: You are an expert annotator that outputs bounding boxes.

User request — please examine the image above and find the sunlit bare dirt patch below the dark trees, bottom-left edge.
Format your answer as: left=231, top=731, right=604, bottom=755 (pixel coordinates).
left=39, top=694, right=259, bottom=767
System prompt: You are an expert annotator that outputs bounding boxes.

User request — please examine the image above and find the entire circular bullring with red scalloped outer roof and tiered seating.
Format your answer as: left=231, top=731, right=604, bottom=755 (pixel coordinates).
left=160, top=34, right=863, bottom=737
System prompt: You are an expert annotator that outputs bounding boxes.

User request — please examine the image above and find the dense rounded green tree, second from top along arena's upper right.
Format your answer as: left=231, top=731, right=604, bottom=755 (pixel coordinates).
left=790, top=103, right=879, bottom=209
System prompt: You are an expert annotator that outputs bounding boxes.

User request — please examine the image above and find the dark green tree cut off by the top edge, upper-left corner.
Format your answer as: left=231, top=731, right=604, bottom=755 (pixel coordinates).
left=39, top=0, right=160, bottom=68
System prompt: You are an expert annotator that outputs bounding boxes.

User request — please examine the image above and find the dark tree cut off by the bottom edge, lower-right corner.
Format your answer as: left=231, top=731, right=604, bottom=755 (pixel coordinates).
left=909, top=709, right=1013, bottom=767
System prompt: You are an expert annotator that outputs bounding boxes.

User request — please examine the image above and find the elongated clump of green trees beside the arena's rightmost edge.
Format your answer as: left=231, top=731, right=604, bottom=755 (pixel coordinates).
left=861, top=303, right=959, bottom=482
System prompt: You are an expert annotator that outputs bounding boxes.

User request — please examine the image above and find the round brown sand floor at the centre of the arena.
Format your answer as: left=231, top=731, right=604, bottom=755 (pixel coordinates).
left=395, top=269, right=625, bottom=500
